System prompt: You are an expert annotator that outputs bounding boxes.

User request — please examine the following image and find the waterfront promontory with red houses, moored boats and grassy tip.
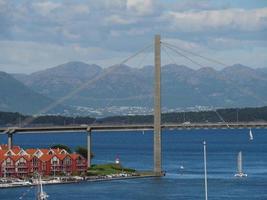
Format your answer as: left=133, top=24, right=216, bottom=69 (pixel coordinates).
left=0, top=142, right=157, bottom=188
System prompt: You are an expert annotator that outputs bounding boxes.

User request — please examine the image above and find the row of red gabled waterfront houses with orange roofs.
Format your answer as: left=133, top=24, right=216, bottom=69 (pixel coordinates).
left=0, top=145, right=87, bottom=177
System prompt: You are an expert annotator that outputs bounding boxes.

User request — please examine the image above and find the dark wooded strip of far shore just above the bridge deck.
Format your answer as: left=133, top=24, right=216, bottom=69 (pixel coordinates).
left=0, top=106, right=267, bottom=127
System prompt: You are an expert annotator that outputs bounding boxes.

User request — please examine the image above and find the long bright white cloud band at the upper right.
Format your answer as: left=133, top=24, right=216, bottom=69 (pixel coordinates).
left=162, top=8, right=267, bottom=32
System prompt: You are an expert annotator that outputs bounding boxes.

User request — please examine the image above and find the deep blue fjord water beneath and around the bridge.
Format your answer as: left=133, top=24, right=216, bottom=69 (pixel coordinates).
left=0, top=129, right=267, bottom=200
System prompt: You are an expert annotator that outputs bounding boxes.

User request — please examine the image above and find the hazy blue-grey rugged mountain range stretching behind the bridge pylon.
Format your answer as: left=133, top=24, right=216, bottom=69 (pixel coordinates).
left=11, top=62, right=267, bottom=111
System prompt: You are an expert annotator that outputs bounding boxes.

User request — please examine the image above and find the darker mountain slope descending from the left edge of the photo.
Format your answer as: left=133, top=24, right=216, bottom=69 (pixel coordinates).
left=0, top=72, right=63, bottom=114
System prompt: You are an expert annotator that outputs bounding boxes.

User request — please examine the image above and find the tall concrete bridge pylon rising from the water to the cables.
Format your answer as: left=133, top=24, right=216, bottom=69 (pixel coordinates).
left=154, top=35, right=162, bottom=176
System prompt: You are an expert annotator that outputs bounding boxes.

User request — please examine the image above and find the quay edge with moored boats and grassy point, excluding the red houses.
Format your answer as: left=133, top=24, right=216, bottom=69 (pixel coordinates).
left=0, top=163, right=154, bottom=189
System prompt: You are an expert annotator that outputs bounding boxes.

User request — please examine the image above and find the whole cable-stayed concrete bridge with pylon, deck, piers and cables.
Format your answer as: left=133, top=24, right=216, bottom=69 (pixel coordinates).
left=0, top=35, right=267, bottom=176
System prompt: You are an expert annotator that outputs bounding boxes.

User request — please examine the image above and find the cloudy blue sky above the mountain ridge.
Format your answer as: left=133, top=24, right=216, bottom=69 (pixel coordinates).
left=0, top=0, right=267, bottom=73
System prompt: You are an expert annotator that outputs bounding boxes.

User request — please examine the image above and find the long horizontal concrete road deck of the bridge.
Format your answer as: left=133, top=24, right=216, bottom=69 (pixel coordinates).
left=0, top=122, right=267, bottom=134
